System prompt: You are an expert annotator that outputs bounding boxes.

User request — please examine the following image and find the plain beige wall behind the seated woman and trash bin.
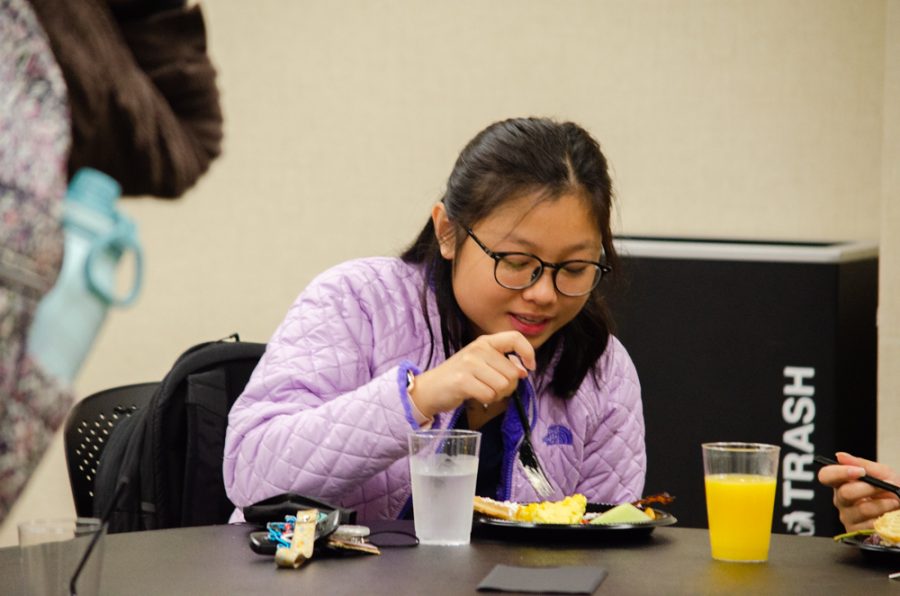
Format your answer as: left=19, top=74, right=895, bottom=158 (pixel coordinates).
left=0, top=0, right=900, bottom=544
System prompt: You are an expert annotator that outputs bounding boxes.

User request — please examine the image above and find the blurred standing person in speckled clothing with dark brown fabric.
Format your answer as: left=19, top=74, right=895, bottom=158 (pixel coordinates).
left=0, top=0, right=222, bottom=522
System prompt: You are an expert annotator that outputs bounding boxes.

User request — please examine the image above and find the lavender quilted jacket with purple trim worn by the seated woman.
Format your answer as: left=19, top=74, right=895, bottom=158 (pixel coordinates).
left=224, top=258, right=646, bottom=519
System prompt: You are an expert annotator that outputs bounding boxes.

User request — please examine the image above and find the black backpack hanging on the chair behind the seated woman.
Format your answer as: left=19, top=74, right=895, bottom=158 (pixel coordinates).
left=94, top=334, right=266, bottom=533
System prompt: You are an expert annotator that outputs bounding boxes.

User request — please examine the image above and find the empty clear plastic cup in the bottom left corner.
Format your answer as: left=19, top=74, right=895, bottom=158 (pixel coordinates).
left=19, top=517, right=106, bottom=596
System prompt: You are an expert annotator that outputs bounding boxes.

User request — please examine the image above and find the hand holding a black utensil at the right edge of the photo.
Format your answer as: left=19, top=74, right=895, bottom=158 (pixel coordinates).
left=819, top=452, right=900, bottom=532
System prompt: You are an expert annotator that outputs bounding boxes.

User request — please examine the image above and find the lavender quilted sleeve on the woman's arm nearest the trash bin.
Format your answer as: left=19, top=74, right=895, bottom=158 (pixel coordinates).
left=577, top=337, right=647, bottom=503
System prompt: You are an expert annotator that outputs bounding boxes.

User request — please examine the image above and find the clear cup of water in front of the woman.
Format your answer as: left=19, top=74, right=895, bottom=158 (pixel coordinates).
left=409, top=430, right=481, bottom=545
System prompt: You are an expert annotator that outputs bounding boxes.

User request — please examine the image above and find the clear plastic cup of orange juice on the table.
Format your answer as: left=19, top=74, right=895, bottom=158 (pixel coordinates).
left=702, top=443, right=780, bottom=563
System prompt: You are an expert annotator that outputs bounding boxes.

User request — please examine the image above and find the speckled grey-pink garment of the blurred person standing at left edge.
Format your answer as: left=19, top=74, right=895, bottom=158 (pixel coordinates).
left=0, top=0, right=72, bottom=521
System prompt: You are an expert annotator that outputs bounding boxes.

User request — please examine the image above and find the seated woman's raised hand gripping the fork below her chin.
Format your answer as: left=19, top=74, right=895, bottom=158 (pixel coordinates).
left=410, top=331, right=536, bottom=418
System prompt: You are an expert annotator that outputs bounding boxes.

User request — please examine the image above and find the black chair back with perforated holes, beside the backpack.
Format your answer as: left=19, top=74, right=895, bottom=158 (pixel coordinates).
left=63, top=382, right=159, bottom=517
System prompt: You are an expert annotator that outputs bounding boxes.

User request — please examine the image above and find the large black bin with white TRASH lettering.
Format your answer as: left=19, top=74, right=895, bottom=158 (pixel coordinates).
left=608, top=237, right=878, bottom=536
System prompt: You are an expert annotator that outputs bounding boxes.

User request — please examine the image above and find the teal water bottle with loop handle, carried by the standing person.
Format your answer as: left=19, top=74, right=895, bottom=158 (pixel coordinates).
left=28, top=168, right=143, bottom=384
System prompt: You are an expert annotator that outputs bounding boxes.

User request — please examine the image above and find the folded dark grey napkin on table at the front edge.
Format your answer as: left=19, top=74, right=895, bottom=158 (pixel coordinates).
left=478, top=565, right=606, bottom=594
